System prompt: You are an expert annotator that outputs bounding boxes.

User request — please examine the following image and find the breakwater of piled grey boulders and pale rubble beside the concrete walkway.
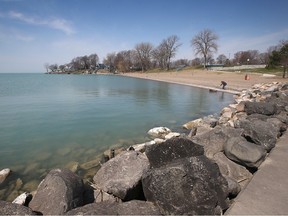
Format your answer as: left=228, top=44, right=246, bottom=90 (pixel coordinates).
left=0, top=83, right=288, bottom=215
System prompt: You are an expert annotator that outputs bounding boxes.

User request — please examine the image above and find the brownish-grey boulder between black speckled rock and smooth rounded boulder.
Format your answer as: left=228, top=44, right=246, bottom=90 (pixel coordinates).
left=191, top=126, right=243, bottom=159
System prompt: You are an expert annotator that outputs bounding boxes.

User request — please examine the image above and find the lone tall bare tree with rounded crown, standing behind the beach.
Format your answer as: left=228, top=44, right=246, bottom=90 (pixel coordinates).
left=191, top=29, right=218, bottom=68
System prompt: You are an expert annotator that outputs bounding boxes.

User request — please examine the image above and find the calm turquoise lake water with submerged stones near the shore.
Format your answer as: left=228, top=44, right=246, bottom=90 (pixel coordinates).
left=0, top=74, right=233, bottom=200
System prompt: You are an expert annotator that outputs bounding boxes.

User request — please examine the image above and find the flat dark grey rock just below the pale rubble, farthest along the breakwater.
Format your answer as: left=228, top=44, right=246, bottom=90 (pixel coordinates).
left=244, top=101, right=277, bottom=116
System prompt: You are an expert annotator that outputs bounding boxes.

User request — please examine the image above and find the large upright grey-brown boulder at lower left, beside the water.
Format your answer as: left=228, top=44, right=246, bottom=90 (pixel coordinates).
left=29, top=169, right=84, bottom=215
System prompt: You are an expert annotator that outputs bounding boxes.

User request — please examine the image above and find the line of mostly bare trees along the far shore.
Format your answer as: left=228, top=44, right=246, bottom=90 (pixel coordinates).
left=44, top=29, right=288, bottom=76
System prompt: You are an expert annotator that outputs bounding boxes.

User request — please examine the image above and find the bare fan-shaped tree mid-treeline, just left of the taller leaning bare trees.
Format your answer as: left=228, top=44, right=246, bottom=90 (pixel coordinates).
left=135, top=43, right=153, bottom=71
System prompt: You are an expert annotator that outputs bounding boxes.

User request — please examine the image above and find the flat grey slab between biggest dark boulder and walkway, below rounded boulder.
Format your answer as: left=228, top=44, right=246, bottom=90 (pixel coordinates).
left=213, top=152, right=252, bottom=187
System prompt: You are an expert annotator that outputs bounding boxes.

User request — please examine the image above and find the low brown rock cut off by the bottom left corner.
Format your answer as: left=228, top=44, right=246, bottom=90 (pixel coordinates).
left=0, top=200, right=37, bottom=215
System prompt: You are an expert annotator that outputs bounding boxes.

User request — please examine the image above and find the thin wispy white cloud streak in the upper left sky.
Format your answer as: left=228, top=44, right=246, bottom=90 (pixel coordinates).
left=9, top=11, right=75, bottom=35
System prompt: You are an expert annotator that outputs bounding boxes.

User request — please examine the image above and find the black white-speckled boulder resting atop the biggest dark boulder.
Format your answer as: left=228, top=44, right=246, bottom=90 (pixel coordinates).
left=145, top=137, right=204, bottom=167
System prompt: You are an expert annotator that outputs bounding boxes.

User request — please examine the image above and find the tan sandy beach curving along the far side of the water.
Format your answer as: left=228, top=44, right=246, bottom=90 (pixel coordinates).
left=122, top=69, right=288, bottom=93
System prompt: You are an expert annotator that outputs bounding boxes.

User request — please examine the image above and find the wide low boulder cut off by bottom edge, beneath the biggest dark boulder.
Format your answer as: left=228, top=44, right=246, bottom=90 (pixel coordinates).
left=67, top=200, right=161, bottom=215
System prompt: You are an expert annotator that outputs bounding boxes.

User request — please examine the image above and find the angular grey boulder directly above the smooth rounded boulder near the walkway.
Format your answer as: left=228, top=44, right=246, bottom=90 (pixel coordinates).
left=237, top=119, right=280, bottom=152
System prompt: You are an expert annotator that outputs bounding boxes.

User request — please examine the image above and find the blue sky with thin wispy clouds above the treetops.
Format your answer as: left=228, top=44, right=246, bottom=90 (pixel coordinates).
left=0, top=0, right=288, bottom=73
